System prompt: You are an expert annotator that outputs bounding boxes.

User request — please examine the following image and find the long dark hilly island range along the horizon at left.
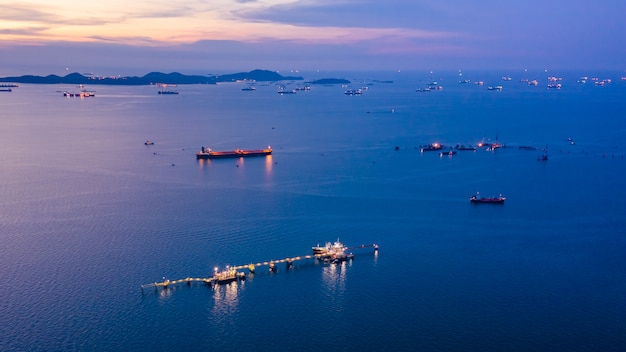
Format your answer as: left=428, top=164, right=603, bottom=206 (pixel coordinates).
left=0, top=70, right=304, bottom=86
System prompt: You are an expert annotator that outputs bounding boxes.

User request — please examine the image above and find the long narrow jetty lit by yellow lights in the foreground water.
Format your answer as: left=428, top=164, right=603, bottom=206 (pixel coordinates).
left=141, top=240, right=378, bottom=290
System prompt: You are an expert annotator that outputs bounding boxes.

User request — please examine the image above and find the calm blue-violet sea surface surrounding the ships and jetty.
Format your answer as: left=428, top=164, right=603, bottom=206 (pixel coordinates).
left=0, top=70, right=626, bottom=352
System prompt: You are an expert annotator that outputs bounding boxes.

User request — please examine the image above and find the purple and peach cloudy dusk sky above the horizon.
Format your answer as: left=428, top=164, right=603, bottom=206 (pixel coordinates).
left=0, top=0, right=626, bottom=76
